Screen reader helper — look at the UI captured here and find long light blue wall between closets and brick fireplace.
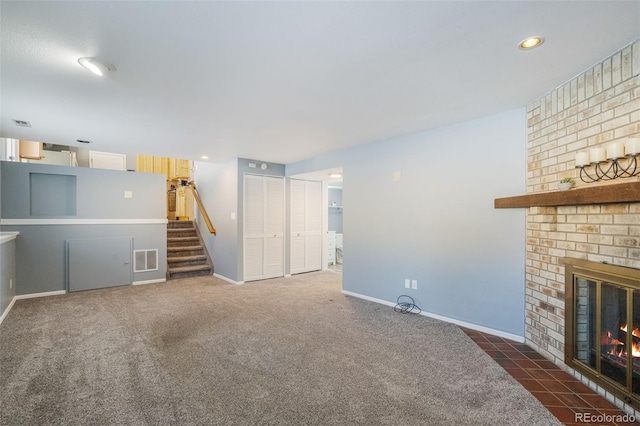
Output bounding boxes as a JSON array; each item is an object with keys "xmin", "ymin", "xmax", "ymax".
[{"xmin": 287, "ymin": 109, "xmax": 526, "ymax": 336}]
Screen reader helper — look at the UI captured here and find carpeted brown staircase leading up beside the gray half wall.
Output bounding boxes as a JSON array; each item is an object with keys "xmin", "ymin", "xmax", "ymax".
[{"xmin": 167, "ymin": 220, "xmax": 213, "ymax": 280}]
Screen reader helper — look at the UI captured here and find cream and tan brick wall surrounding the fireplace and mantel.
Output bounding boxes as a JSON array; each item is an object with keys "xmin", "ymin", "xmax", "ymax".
[{"xmin": 525, "ymin": 40, "xmax": 640, "ymax": 364}]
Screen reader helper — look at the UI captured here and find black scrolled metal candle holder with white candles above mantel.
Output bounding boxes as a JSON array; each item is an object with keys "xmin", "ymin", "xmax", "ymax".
[{"xmin": 576, "ymin": 138, "xmax": 640, "ymax": 183}]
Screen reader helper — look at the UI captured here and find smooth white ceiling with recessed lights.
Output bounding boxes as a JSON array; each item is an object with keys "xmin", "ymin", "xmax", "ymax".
[{"xmin": 0, "ymin": 0, "xmax": 640, "ymax": 163}]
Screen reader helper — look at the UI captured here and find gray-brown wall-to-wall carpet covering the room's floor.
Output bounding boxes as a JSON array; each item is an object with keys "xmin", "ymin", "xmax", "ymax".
[{"xmin": 0, "ymin": 272, "xmax": 560, "ymax": 425}]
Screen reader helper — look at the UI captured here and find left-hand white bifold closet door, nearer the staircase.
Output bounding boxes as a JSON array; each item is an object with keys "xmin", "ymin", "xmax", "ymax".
[{"xmin": 243, "ymin": 175, "xmax": 285, "ymax": 281}]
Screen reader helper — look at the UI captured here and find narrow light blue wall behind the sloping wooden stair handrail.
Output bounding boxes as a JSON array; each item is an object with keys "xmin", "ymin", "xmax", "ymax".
[{"xmin": 194, "ymin": 159, "xmax": 241, "ymax": 281}]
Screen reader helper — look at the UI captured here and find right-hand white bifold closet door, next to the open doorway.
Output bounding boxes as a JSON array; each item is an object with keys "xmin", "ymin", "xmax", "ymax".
[{"xmin": 290, "ymin": 180, "xmax": 322, "ymax": 274}]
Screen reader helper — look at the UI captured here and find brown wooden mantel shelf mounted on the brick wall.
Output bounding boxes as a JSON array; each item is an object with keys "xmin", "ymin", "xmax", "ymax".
[{"xmin": 494, "ymin": 182, "xmax": 640, "ymax": 209}]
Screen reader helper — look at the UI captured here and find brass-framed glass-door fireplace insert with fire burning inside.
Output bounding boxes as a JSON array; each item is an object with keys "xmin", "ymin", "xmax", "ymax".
[{"xmin": 565, "ymin": 259, "xmax": 640, "ymax": 407}]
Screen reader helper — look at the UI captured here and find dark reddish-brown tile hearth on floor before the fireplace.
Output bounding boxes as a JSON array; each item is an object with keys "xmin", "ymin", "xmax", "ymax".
[{"xmin": 461, "ymin": 327, "xmax": 640, "ymax": 425}]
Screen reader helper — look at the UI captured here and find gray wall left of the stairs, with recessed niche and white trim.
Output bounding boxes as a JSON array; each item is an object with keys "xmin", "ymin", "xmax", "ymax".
[{"xmin": 0, "ymin": 162, "xmax": 167, "ymax": 295}]
